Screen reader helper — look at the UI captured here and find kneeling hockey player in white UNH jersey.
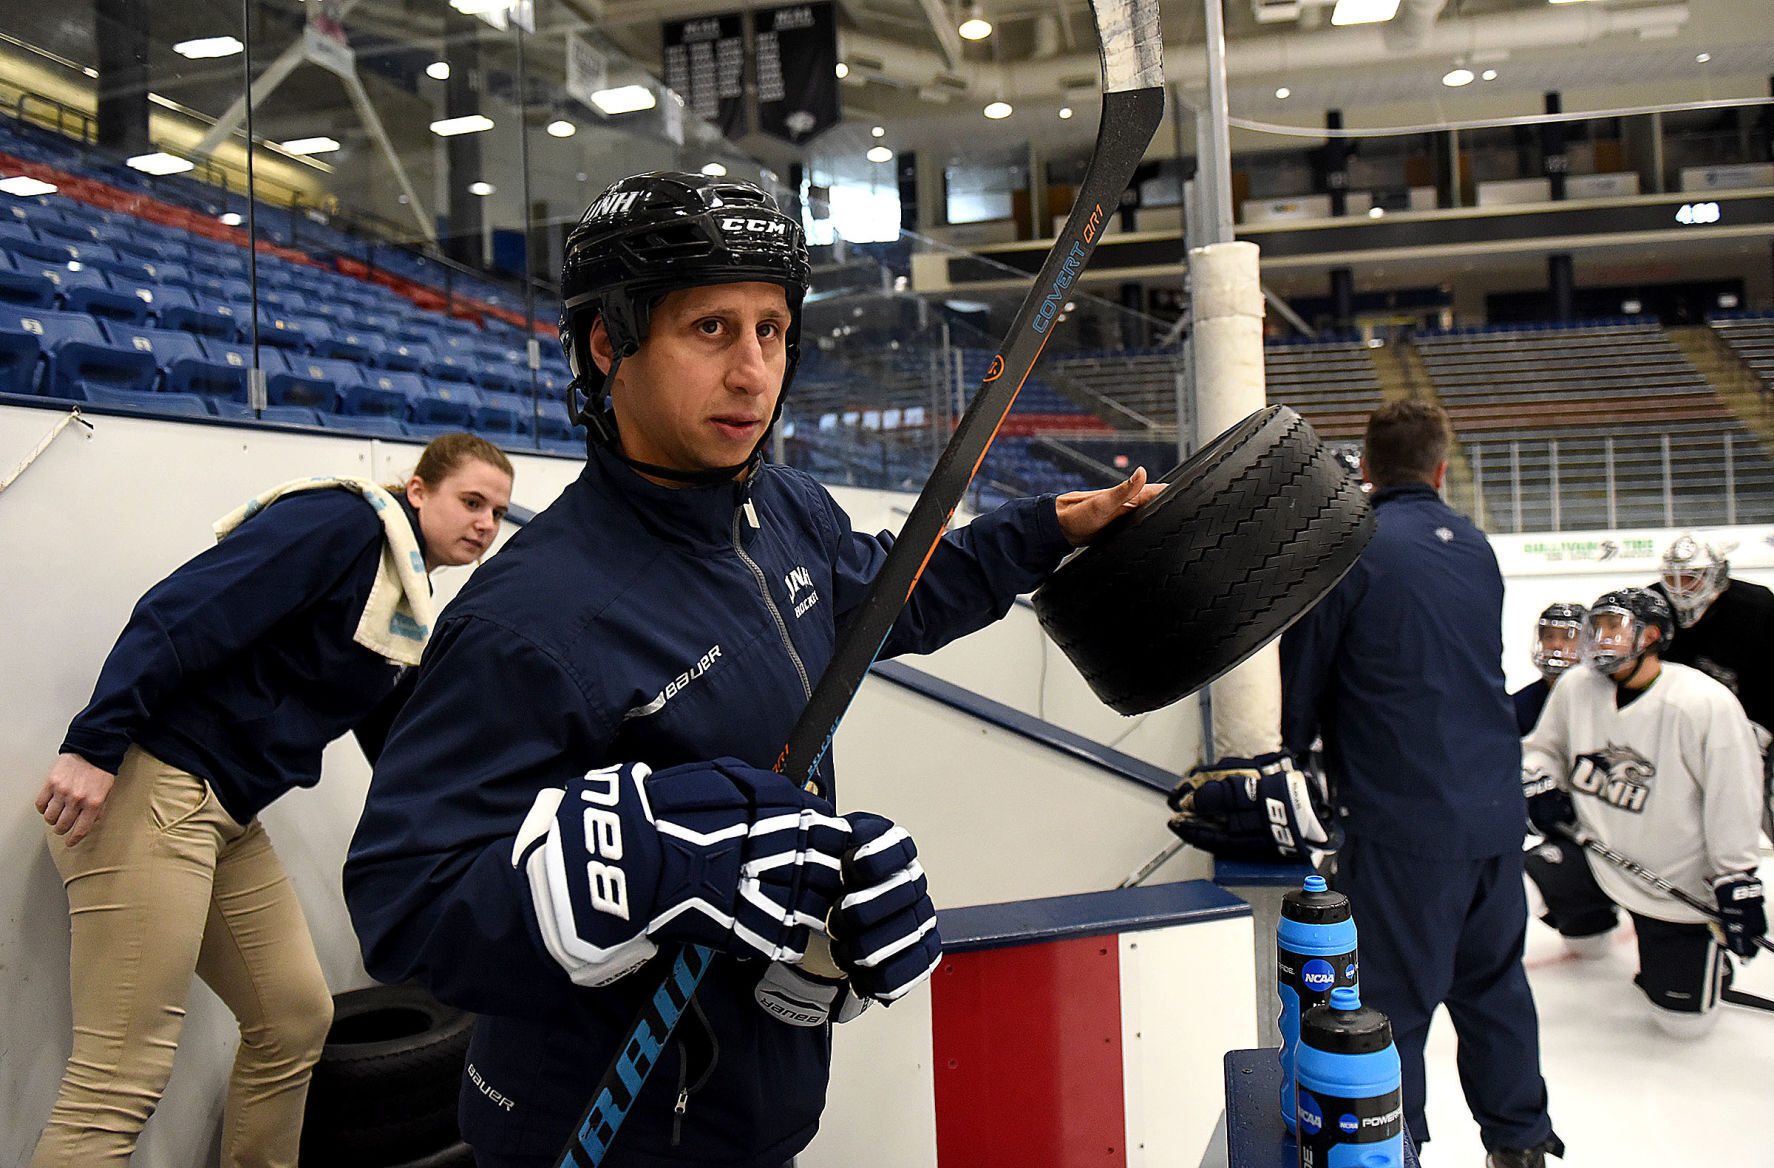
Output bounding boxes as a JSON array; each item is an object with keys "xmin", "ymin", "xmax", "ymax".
[{"xmin": 1522, "ymin": 588, "xmax": 1767, "ymax": 1037}]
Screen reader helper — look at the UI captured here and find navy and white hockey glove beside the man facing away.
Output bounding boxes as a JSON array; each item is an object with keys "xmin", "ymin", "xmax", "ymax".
[{"xmin": 1167, "ymin": 751, "xmax": 1341, "ymax": 861}]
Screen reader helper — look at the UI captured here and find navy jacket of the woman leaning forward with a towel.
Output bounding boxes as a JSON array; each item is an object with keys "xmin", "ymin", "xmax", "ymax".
[{"xmin": 62, "ymin": 488, "xmax": 424, "ymax": 824}]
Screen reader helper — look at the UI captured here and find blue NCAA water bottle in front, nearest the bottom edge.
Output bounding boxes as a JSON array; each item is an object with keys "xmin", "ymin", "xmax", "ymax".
[{"xmin": 1297, "ymin": 985, "xmax": 1405, "ymax": 1168}]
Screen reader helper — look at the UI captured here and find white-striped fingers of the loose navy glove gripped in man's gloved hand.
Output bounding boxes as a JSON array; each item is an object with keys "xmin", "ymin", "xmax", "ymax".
[{"xmin": 832, "ymin": 811, "xmax": 942, "ymax": 1003}]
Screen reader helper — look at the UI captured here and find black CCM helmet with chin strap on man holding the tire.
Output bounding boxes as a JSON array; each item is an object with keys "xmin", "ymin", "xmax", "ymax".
[{"xmin": 561, "ymin": 170, "xmax": 812, "ymax": 483}]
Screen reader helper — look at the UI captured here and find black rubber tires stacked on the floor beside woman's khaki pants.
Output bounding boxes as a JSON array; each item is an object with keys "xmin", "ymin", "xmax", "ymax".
[{"xmin": 302, "ymin": 985, "xmax": 474, "ymax": 1168}]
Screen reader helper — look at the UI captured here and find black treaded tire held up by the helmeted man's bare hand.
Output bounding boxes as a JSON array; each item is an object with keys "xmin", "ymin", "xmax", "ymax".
[{"xmin": 1034, "ymin": 405, "xmax": 1373, "ymax": 714}]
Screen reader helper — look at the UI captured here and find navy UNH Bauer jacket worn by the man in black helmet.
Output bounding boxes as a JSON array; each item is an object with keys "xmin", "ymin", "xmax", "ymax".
[{"xmin": 344, "ymin": 441, "xmax": 1068, "ymax": 1168}]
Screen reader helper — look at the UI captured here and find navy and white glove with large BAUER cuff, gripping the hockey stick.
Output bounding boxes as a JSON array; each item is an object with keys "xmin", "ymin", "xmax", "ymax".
[{"xmin": 511, "ymin": 758, "xmax": 852, "ymax": 985}]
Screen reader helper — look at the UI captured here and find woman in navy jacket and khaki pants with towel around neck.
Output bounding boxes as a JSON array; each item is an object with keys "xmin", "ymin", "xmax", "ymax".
[{"xmin": 32, "ymin": 435, "xmax": 511, "ymax": 1168}]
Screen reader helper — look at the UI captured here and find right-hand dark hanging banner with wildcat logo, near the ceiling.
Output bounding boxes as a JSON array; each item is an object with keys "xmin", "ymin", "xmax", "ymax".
[{"xmin": 752, "ymin": 0, "xmax": 843, "ymax": 146}]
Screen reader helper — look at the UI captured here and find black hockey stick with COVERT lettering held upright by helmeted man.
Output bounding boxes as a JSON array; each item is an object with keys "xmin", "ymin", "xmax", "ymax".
[{"xmin": 557, "ymin": 9, "xmax": 1164, "ymax": 1168}]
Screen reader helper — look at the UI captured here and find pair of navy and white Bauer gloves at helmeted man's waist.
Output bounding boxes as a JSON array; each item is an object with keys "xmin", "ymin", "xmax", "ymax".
[{"xmin": 511, "ymin": 758, "xmax": 942, "ymax": 1026}]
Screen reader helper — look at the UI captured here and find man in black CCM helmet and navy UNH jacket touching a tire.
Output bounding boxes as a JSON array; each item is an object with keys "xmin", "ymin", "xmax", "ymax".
[{"xmin": 346, "ymin": 165, "xmax": 1157, "ymax": 1168}]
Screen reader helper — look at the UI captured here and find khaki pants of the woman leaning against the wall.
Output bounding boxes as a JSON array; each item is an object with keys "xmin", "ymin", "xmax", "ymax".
[{"xmin": 32, "ymin": 747, "xmax": 332, "ymax": 1168}]
